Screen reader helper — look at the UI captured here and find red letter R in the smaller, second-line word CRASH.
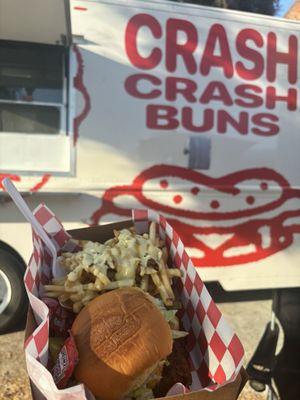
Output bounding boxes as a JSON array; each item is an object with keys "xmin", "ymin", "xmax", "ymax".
[{"xmin": 166, "ymin": 77, "xmax": 197, "ymax": 103}]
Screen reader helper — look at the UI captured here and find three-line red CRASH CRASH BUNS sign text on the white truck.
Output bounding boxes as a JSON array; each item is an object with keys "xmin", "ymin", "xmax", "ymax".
[{"xmin": 124, "ymin": 14, "xmax": 298, "ymax": 137}]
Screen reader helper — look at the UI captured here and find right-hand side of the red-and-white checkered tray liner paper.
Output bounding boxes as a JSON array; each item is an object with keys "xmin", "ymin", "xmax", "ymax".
[{"xmin": 133, "ymin": 210, "xmax": 244, "ymax": 390}]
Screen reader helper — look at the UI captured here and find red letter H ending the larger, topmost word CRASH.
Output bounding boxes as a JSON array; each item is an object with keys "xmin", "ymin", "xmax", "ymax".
[{"xmin": 267, "ymin": 32, "xmax": 298, "ymax": 84}]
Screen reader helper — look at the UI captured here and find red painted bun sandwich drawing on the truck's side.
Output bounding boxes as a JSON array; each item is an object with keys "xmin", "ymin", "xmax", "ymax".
[{"xmin": 91, "ymin": 165, "xmax": 300, "ymax": 267}]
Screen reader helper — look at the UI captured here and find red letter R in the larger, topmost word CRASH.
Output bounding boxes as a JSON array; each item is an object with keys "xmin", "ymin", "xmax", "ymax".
[{"xmin": 166, "ymin": 18, "xmax": 198, "ymax": 74}]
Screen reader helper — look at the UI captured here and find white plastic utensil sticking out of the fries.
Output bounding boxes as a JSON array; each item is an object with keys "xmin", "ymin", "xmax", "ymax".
[{"xmin": 2, "ymin": 178, "xmax": 65, "ymax": 277}]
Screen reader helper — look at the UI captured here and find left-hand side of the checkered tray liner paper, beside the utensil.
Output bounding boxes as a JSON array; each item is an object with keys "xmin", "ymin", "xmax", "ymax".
[{"xmin": 24, "ymin": 204, "xmax": 87, "ymax": 400}]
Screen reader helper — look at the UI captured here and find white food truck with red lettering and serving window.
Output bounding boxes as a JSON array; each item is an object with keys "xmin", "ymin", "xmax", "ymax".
[{"xmin": 0, "ymin": 0, "xmax": 300, "ymax": 338}]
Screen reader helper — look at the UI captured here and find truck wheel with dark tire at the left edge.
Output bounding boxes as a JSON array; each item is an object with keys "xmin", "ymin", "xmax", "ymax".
[{"xmin": 0, "ymin": 249, "xmax": 28, "ymax": 334}]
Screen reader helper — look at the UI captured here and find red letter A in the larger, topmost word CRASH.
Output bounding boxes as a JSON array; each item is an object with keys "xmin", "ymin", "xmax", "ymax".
[{"xmin": 200, "ymin": 24, "xmax": 233, "ymax": 78}]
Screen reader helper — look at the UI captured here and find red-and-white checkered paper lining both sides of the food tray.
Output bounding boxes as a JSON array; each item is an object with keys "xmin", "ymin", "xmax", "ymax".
[{"xmin": 24, "ymin": 205, "xmax": 244, "ymax": 400}]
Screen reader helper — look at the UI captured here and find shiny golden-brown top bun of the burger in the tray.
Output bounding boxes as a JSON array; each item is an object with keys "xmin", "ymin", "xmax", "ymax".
[{"xmin": 71, "ymin": 288, "xmax": 172, "ymax": 400}]
